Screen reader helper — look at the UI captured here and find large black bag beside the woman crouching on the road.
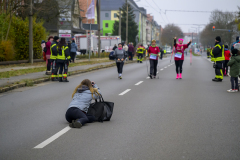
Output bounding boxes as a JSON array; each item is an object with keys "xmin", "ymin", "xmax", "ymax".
[{"xmin": 87, "ymin": 95, "xmax": 114, "ymax": 122}]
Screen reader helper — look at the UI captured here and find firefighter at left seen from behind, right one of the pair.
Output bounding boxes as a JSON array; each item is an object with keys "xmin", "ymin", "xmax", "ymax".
[{"xmin": 55, "ymin": 38, "xmax": 71, "ymax": 82}]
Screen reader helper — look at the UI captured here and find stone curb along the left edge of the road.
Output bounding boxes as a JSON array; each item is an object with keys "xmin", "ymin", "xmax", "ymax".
[{"xmin": 0, "ymin": 60, "xmax": 136, "ymax": 93}]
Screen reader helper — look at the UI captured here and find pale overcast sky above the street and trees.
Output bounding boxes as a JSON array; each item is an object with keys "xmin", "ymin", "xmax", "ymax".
[{"xmin": 135, "ymin": 0, "xmax": 240, "ymax": 32}]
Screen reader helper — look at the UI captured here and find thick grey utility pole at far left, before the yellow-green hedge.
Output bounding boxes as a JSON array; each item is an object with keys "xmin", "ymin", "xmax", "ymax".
[{"xmin": 29, "ymin": 0, "xmax": 33, "ymax": 64}]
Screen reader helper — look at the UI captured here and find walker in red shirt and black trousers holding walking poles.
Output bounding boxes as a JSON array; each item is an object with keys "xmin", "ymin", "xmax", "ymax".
[{"xmin": 148, "ymin": 40, "xmax": 160, "ymax": 79}]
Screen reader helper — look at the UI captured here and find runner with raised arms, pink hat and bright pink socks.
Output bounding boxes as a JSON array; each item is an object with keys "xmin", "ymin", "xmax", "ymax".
[{"xmin": 174, "ymin": 37, "xmax": 192, "ymax": 79}]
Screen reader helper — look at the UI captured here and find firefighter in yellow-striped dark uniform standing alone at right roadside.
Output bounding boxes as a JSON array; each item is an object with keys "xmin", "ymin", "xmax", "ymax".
[{"xmin": 211, "ymin": 36, "xmax": 225, "ymax": 82}]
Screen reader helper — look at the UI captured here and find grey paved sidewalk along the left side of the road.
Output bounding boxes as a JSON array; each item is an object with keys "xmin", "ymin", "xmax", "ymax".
[{"xmin": 0, "ymin": 60, "xmax": 115, "ymax": 87}]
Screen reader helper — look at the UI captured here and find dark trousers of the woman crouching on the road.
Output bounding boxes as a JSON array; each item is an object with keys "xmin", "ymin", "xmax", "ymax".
[{"xmin": 65, "ymin": 107, "xmax": 95, "ymax": 125}]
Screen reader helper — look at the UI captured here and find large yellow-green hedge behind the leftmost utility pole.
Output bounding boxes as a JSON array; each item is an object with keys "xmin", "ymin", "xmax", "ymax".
[{"xmin": 0, "ymin": 14, "xmax": 47, "ymax": 60}]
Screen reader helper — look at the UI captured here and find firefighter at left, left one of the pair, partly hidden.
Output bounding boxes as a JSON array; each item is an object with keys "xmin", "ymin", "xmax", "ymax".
[{"xmin": 48, "ymin": 36, "xmax": 59, "ymax": 81}]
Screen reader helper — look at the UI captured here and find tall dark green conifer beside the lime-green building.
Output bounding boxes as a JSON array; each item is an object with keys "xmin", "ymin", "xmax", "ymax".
[{"xmin": 113, "ymin": 0, "xmax": 138, "ymax": 44}]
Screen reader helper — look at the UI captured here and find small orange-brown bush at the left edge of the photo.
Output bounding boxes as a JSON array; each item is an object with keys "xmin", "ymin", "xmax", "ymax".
[{"xmin": 0, "ymin": 40, "xmax": 15, "ymax": 61}]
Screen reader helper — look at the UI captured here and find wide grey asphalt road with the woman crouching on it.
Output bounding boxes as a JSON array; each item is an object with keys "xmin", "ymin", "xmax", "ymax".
[{"xmin": 0, "ymin": 53, "xmax": 240, "ymax": 160}]
